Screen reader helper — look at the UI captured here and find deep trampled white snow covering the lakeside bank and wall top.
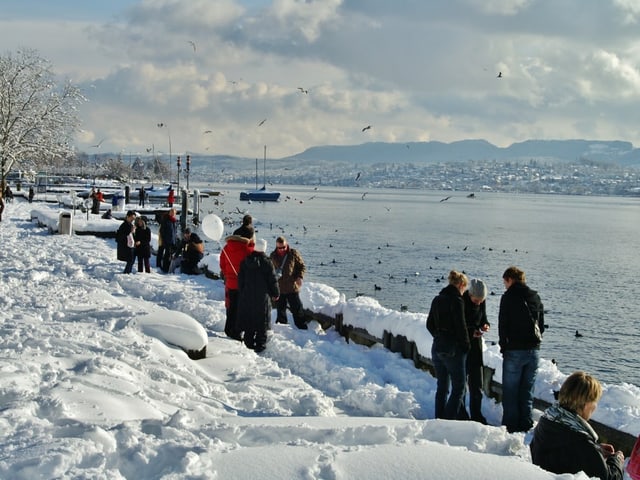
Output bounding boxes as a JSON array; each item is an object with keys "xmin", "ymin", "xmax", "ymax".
[{"xmin": 0, "ymin": 193, "xmax": 640, "ymax": 480}]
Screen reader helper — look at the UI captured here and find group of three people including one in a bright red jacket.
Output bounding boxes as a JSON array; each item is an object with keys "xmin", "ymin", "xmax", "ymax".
[{"xmin": 220, "ymin": 215, "xmax": 308, "ymax": 352}]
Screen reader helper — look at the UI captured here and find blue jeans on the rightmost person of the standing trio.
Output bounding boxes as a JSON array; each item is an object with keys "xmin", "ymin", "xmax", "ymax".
[{"xmin": 502, "ymin": 349, "xmax": 540, "ymax": 432}]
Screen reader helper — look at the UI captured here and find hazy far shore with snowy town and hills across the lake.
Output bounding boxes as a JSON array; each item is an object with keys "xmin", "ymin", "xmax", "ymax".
[{"xmin": 16, "ymin": 140, "xmax": 640, "ymax": 197}]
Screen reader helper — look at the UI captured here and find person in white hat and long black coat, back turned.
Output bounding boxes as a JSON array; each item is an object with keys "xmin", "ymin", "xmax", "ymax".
[{"xmin": 238, "ymin": 238, "xmax": 280, "ymax": 353}]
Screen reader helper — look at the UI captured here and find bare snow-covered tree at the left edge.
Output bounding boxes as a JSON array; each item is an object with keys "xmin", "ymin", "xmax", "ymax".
[{"xmin": 0, "ymin": 49, "xmax": 86, "ymax": 185}]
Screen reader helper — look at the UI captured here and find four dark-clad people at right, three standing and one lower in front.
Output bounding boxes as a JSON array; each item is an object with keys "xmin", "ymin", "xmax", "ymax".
[{"xmin": 427, "ymin": 266, "xmax": 624, "ymax": 480}]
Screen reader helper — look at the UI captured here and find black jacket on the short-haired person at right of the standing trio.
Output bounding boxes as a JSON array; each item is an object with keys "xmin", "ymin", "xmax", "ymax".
[{"xmin": 498, "ymin": 283, "xmax": 544, "ymax": 352}]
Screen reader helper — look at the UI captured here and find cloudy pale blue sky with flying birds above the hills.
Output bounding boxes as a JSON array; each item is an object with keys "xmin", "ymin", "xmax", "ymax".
[{"xmin": 0, "ymin": 0, "xmax": 640, "ymax": 158}]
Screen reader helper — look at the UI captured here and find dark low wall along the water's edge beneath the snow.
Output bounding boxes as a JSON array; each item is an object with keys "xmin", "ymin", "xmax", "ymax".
[{"xmin": 307, "ymin": 310, "xmax": 636, "ymax": 456}]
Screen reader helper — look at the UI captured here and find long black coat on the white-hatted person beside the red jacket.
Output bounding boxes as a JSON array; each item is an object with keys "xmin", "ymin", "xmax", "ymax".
[{"xmin": 238, "ymin": 252, "xmax": 280, "ymax": 330}]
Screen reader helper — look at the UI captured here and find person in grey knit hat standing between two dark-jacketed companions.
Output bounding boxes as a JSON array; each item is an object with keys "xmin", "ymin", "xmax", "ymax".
[{"xmin": 462, "ymin": 278, "xmax": 490, "ymax": 425}]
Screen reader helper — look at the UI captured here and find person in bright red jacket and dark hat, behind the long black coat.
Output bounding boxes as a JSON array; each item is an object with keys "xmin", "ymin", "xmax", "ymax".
[{"xmin": 220, "ymin": 228, "xmax": 255, "ymax": 341}]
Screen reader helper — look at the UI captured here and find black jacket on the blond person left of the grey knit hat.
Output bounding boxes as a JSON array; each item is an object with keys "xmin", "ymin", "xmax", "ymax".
[{"xmin": 427, "ymin": 285, "xmax": 470, "ymax": 352}]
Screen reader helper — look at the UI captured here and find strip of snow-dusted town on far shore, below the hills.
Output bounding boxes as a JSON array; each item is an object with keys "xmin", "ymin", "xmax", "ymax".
[{"xmin": 220, "ymin": 160, "xmax": 640, "ymax": 196}]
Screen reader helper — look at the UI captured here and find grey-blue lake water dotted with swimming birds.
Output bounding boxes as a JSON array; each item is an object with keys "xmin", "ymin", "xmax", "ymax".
[{"xmin": 201, "ymin": 185, "xmax": 640, "ymax": 385}]
